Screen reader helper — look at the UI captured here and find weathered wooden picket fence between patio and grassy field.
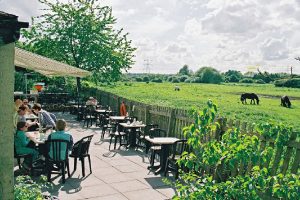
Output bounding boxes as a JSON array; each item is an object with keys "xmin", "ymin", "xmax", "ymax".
[{"xmin": 90, "ymin": 90, "xmax": 300, "ymax": 176}]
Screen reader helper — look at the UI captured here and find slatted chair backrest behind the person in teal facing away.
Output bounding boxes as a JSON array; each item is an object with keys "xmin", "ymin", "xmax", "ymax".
[{"xmin": 46, "ymin": 139, "xmax": 69, "ymax": 161}]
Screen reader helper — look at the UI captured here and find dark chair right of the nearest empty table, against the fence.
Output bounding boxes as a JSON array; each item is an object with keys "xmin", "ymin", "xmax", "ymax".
[{"xmin": 164, "ymin": 139, "xmax": 187, "ymax": 179}]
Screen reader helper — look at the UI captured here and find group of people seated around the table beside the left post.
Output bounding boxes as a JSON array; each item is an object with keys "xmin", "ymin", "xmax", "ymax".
[{"xmin": 14, "ymin": 99, "xmax": 73, "ymax": 170}]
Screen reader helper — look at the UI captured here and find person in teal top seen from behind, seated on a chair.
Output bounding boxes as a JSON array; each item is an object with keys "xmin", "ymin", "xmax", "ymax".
[{"xmin": 48, "ymin": 119, "xmax": 73, "ymax": 158}]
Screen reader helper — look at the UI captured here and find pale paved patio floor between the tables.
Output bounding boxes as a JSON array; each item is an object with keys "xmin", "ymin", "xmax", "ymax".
[{"xmin": 15, "ymin": 113, "xmax": 175, "ymax": 200}]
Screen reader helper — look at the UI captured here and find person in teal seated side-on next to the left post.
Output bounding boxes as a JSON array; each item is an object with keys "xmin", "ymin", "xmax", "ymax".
[{"xmin": 15, "ymin": 122, "xmax": 39, "ymax": 170}]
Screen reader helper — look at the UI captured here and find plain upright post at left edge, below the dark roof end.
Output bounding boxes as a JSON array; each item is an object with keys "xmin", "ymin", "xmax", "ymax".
[{"xmin": 0, "ymin": 43, "xmax": 15, "ymax": 199}]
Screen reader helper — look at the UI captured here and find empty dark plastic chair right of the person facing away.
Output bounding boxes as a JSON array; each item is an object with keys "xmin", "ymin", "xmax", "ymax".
[{"xmin": 69, "ymin": 135, "xmax": 94, "ymax": 176}]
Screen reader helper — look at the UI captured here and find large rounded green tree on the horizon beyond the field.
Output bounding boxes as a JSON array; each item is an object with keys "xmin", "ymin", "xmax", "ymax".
[{"xmin": 195, "ymin": 67, "xmax": 223, "ymax": 83}]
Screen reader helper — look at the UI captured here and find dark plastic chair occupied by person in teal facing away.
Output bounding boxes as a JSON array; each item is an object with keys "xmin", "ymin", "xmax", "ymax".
[{"xmin": 46, "ymin": 139, "xmax": 71, "ymax": 183}]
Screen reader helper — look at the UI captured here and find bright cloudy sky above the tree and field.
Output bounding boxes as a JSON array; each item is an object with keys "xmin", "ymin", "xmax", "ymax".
[{"xmin": 0, "ymin": 0, "xmax": 300, "ymax": 74}]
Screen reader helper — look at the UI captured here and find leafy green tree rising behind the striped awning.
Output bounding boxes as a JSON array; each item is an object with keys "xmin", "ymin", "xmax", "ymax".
[{"xmin": 22, "ymin": 0, "xmax": 135, "ymax": 82}]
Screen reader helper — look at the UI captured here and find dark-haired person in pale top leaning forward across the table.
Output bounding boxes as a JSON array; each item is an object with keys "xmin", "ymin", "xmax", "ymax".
[{"xmin": 32, "ymin": 103, "xmax": 56, "ymax": 128}]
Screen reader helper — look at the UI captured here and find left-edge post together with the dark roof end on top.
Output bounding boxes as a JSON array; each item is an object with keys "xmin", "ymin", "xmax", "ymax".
[{"xmin": 0, "ymin": 12, "xmax": 29, "ymax": 200}]
